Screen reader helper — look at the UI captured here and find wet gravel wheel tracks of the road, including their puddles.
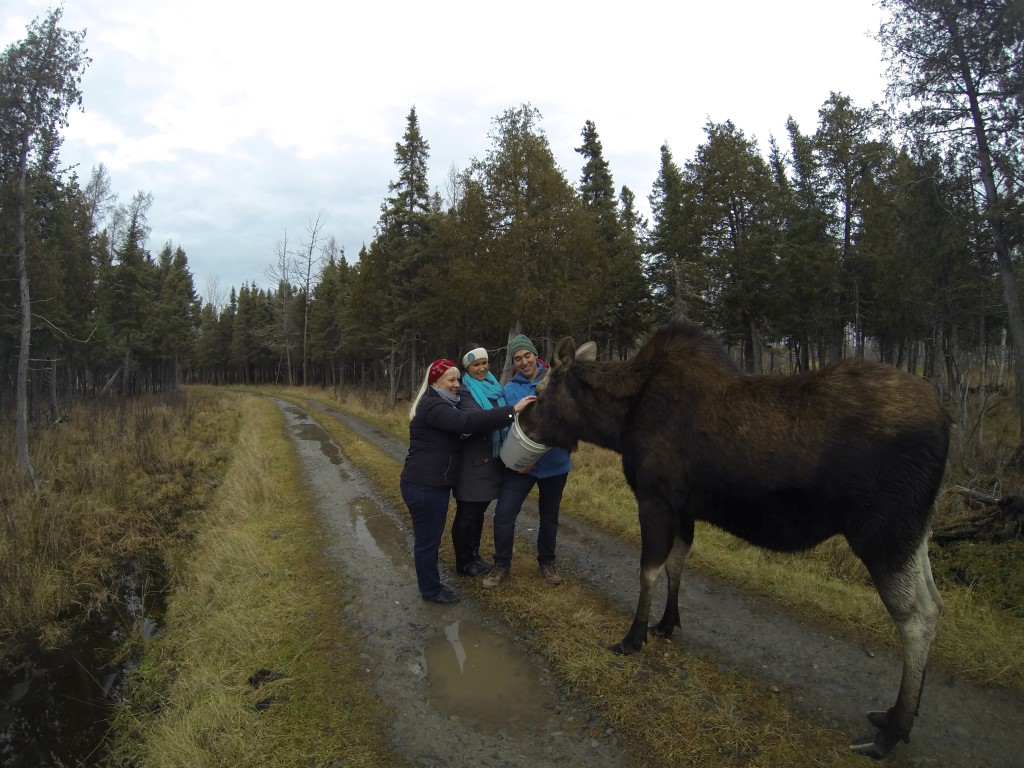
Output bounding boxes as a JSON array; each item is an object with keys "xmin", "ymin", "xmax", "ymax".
[{"xmin": 276, "ymin": 400, "xmax": 1024, "ymax": 768}]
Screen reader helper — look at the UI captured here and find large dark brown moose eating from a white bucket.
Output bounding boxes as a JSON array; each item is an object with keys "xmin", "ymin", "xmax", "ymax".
[{"xmin": 520, "ymin": 323, "xmax": 950, "ymax": 759}]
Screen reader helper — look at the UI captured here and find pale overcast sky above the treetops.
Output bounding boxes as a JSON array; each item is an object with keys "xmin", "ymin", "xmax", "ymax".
[{"xmin": 0, "ymin": 0, "xmax": 885, "ymax": 299}]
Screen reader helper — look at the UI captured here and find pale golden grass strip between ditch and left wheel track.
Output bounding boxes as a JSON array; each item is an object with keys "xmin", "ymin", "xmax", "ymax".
[{"xmin": 108, "ymin": 397, "xmax": 403, "ymax": 768}]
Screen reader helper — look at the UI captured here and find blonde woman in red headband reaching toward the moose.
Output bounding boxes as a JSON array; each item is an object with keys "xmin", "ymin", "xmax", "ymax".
[{"xmin": 400, "ymin": 357, "xmax": 537, "ymax": 603}]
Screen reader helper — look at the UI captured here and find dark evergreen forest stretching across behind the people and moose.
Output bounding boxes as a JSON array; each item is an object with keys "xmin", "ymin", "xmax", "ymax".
[{"xmin": 0, "ymin": 0, "xmax": 1024, "ymax": 475}]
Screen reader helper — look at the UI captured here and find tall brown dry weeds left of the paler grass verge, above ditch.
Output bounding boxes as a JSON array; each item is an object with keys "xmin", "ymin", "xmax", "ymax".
[{"xmin": 0, "ymin": 394, "xmax": 234, "ymax": 657}]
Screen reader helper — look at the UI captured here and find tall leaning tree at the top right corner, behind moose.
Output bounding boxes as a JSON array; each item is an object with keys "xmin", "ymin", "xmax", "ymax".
[{"xmin": 878, "ymin": 0, "xmax": 1024, "ymax": 450}]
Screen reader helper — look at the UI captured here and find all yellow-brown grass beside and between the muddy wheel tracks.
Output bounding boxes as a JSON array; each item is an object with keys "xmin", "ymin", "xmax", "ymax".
[{"xmin": 0, "ymin": 388, "xmax": 1024, "ymax": 768}]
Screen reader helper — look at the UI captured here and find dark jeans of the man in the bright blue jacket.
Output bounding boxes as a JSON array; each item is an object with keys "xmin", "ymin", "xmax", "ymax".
[{"xmin": 495, "ymin": 469, "xmax": 568, "ymax": 567}]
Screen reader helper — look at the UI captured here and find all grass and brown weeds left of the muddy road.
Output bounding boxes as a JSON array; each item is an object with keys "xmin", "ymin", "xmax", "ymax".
[{"xmin": 0, "ymin": 388, "xmax": 403, "ymax": 768}]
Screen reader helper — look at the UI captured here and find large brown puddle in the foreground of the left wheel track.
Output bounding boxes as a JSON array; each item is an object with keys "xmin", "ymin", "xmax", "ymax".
[{"xmin": 424, "ymin": 622, "xmax": 553, "ymax": 733}]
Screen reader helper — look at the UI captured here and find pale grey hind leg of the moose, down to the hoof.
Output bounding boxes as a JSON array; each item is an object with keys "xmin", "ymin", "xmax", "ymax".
[{"xmin": 850, "ymin": 539, "xmax": 942, "ymax": 759}]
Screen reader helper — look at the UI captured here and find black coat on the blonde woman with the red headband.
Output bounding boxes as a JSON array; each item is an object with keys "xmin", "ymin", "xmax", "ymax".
[{"xmin": 401, "ymin": 387, "xmax": 515, "ymax": 487}]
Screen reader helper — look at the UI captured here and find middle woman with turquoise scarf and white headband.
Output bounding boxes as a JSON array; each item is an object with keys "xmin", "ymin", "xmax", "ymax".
[{"xmin": 452, "ymin": 344, "xmax": 509, "ymax": 577}]
